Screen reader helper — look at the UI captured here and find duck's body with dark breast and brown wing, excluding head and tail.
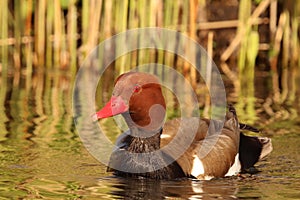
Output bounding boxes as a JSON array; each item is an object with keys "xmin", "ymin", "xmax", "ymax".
[{"xmin": 109, "ymin": 117, "xmax": 239, "ymax": 179}]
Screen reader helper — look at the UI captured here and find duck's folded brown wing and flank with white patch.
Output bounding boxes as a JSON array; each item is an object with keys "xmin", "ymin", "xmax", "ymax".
[{"xmin": 161, "ymin": 108, "xmax": 239, "ymax": 178}]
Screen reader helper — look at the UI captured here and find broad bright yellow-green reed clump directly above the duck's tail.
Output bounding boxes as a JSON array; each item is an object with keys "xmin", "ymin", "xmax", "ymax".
[{"xmin": 237, "ymin": 0, "xmax": 259, "ymax": 122}]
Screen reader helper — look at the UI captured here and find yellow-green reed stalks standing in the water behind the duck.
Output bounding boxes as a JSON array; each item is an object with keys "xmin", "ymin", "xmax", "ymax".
[{"xmin": 0, "ymin": 0, "xmax": 300, "ymax": 120}]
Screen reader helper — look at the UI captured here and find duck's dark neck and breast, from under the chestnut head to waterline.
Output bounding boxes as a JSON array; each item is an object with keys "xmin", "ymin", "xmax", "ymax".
[{"xmin": 110, "ymin": 114, "xmax": 185, "ymax": 179}]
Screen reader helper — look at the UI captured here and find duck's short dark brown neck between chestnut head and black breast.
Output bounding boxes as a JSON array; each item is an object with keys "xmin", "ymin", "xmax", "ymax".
[{"xmin": 126, "ymin": 127, "xmax": 162, "ymax": 153}]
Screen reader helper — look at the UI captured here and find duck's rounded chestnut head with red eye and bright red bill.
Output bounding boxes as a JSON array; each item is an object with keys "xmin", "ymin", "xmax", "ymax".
[{"xmin": 95, "ymin": 72, "xmax": 166, "ymax": 130}]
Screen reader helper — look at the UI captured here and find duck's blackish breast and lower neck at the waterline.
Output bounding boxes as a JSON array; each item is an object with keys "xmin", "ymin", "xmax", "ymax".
[{"xmin": 108, "ymin": 132, "xmax": 185, "ymax": 179}]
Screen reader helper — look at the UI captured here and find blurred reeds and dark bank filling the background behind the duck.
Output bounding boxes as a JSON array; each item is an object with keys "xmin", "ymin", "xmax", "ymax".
[{"xmin": 0, "ymin": 0, "xmax": 300, "ymax": 122}]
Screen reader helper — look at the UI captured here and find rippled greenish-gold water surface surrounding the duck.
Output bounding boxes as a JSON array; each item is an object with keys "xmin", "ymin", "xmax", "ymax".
[{"xmin": 0, "ymin": 73, "xmax": 300, "ymax": 199}]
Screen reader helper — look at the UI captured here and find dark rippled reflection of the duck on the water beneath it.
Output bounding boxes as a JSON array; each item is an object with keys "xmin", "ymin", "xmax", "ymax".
[{"xmin": 105, "ymin": 179, "xmax": 237, "ymax": 199}]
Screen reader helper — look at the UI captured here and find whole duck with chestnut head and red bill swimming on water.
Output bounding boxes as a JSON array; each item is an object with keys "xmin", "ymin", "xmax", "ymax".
[{"xmin": 93, "ymin": 72, "xmax": 272, "ymax": 180}]
